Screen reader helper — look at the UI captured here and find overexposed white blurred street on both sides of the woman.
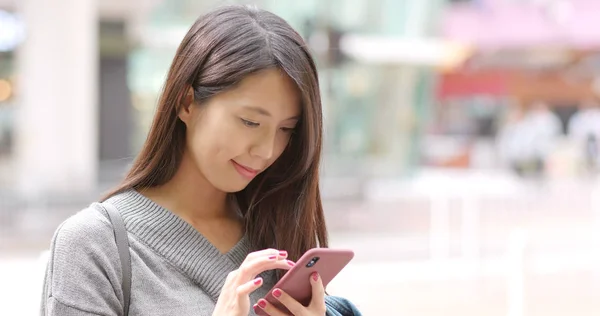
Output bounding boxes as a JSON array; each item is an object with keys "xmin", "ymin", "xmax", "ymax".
[{"xmin": 0, "ymin": 169, "xmax": 600, "ymax": 316}]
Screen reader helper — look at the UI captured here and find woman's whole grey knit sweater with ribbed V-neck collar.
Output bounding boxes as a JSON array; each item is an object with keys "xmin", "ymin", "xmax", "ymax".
[{"xmin": 41, "ymin": 190, "xmax": 275, "ymax": 316}]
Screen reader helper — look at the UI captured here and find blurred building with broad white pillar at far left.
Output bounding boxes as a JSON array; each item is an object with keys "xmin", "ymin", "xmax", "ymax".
[{"xmin": 0, "ymin": 0, "xmax": 156, "ymax": 195}]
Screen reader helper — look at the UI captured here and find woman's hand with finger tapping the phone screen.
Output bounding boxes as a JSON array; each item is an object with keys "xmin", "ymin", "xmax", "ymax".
[{"xmin": 213, "ymin": 249, "xmax": 294, "ymax": 316}]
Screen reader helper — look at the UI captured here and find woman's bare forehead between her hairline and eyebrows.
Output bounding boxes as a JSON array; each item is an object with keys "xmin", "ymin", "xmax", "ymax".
[{"xmin": 214, "ymin": 69, "xmax": 301, "ymax": 118}]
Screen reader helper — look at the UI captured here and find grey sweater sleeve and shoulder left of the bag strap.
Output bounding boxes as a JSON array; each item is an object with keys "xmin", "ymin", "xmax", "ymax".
[{"xmin": 41, "ymin": 206, "xmax": 123, "ymax": 316}]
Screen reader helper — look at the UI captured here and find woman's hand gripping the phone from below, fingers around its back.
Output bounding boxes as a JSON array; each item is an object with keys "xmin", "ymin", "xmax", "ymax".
[{"xmin": 256, "ymin": 272, "xmax": 327, "ymax": 316}]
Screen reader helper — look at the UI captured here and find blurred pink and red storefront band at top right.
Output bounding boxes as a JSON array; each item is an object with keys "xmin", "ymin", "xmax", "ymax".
[{"xmin": 439, "ymin": 0, "xmax": 600, "ymax": 103}]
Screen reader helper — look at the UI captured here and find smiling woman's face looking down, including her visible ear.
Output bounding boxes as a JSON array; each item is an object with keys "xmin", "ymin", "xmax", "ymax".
[{"xmin": 179, "ymin": 69, "xmax": 301, "ymax": 192}]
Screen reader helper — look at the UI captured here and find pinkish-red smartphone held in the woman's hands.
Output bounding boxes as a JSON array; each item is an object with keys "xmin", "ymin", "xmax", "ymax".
[{"xmin": 254, "ymin": 248, "xmax": 354, "ymax": 315}]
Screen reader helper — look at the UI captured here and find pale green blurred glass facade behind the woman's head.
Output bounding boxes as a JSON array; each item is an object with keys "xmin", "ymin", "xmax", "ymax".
[{"xmin": 130, "ymin": 0, "xmax": 443, "ymax": 183}]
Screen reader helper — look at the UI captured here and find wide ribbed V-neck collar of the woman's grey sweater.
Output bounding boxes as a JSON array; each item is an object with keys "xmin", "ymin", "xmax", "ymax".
[{"xmin": 108, "ymin": 190, "xmax": 250, "ymax": 300}]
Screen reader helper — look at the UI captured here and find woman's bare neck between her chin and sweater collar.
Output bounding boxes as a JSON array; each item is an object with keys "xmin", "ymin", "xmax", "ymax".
[{"xmin": 140, "ymin": 153, "xmax": 232, "ymax": 223}]
